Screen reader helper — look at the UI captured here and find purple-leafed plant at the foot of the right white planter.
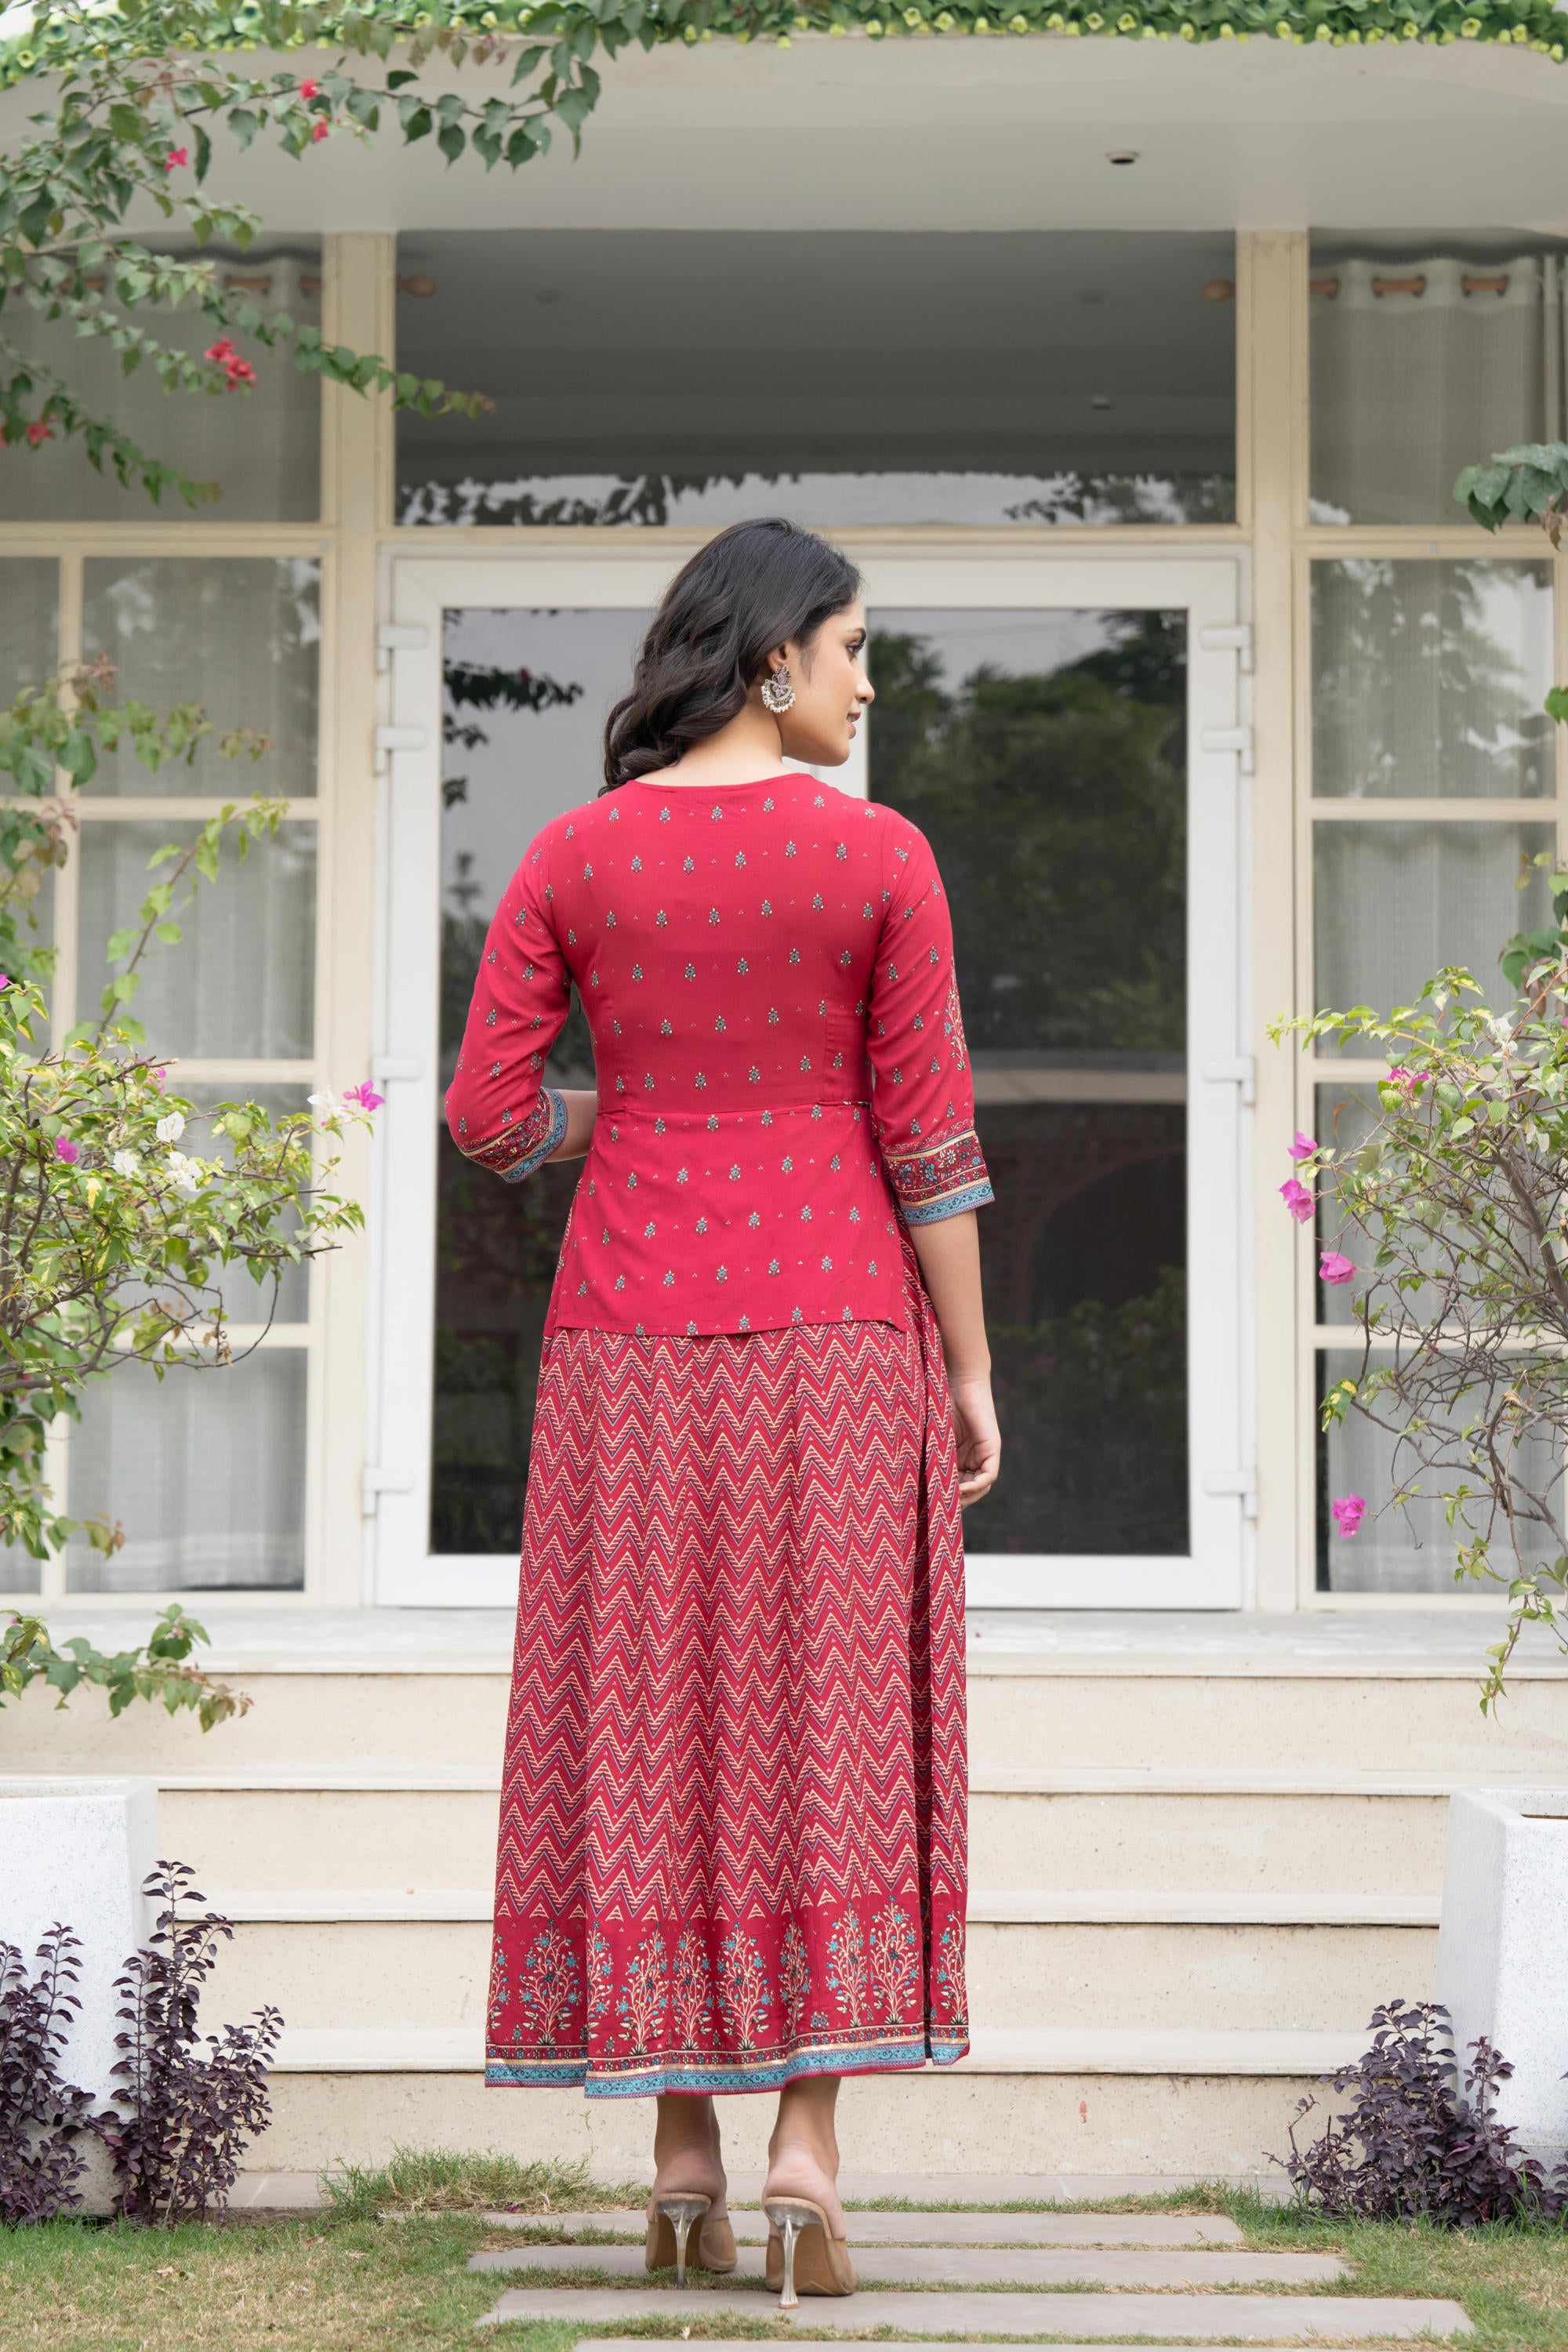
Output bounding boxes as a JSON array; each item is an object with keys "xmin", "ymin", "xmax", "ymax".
[{"xmin": 1269, "ymin": 2002, "xmax": 1566, "ymax": 2230}]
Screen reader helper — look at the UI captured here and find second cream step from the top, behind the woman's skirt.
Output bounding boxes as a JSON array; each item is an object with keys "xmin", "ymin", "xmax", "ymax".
[{"xmin": 160, "ymin": 1769, "xmax": 1504, "ymax": 1898}]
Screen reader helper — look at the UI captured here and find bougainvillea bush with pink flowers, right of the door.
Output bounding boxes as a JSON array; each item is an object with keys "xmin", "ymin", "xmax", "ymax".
[{"xmin": 1269, "ymin": 936, "xmax": 1568, "ymax": 1710}]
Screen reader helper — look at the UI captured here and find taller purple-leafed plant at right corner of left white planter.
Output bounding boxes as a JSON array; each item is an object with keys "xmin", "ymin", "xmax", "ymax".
[{"xmin": 103, "ymin": 1863, "xmax": 282, "ymax": 2227}]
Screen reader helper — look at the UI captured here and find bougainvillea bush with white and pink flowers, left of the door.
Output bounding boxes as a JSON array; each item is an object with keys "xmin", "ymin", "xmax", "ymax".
[{"xmin": 0, "ymin": 666, "xmax": 379, "ymax": 1581}]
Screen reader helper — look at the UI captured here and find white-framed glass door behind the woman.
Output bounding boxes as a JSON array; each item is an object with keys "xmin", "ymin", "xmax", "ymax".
[{"xmin": 367, "ymin": 557, "xmax": 1248, "ymax": 1609}]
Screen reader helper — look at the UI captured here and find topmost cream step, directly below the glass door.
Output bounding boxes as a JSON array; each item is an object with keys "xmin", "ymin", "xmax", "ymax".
[{"xmin": 0, "ymin": 1637, "xmax": 1568, "ymax": 1780}]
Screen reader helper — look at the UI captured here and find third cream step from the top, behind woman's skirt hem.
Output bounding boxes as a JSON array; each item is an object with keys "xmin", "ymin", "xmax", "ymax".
[{"xmin": 199, "ymin": 1891, "xmax": 1436, "ymax": 2030}]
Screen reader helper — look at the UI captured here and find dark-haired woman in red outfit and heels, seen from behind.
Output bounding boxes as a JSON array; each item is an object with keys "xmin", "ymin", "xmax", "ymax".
[{"xmin": 447, "ymin": 522, "xmax": 999, "ymax": 2305}]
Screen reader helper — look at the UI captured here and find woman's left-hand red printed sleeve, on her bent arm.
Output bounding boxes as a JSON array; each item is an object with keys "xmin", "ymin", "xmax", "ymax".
[{"xmin": 447, "ymin": 844, "xmax": 572, "ymax": 1183}]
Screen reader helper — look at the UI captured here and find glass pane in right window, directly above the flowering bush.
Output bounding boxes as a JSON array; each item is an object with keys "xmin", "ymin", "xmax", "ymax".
[{"xmin": 1312, "ymin": 823, "xmax": 1554, "ymax": 1011}]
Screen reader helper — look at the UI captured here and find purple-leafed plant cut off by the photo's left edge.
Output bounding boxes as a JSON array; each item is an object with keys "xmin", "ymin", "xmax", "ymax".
[{"xmin": 0, "ymin": 1922, "xmax": 99, "ymax": 2223}]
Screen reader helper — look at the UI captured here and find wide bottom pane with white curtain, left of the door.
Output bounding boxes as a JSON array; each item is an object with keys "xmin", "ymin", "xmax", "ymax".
[{"xmin": 66, "ymin": 1348, "xmax": 308, "ymax": 1592}]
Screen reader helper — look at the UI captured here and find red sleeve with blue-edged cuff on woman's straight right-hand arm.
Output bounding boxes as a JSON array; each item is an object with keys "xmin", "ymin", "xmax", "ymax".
[{"xmin": 867, "ymin": 823, "xmax": 994, "ymax": 1225}]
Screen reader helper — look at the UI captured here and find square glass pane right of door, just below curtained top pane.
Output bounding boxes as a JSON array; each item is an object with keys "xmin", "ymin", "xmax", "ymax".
[{"xmin": 1312, "ymin": 557, "xmax": 1556, "ymax": 800}]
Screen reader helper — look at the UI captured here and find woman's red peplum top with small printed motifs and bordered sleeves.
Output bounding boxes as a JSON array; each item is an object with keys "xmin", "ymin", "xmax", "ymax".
[{"xmin": 447, "ymin": 774, "xmax": 992, "ymax": 1334}]
